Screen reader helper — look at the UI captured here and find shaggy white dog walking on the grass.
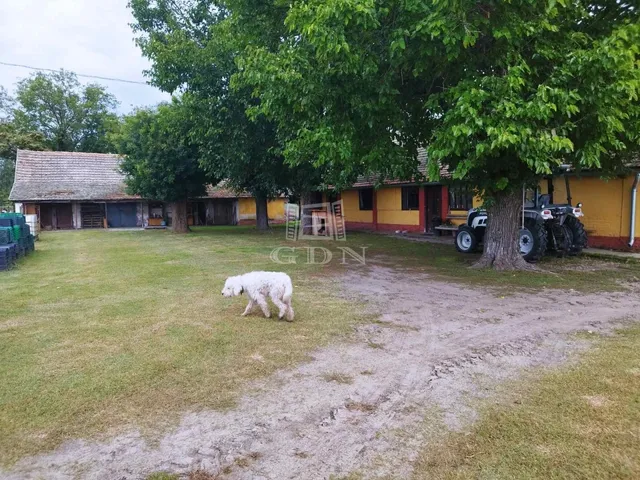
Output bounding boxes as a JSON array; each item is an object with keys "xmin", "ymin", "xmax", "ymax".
[{"xmin": 222, "ymin": 272, "xmax": 293, "ymax": 322}]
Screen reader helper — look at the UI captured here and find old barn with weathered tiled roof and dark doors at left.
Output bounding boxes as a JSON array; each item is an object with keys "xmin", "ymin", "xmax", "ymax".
[{"xmin": 9, "ymin": 150, "xmax": 285, "ymax": 230}]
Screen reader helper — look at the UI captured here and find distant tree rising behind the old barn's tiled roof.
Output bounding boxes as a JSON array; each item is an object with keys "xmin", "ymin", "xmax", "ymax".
[{"xmin": 11, "ymin": 70, "xmax": 118, "ymax": 153}]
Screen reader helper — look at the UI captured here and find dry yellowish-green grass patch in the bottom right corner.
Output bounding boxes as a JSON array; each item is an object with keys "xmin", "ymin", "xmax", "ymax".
[{"xmin": 414, "ymin": 327, "xmax": 640, "ymax": 480}]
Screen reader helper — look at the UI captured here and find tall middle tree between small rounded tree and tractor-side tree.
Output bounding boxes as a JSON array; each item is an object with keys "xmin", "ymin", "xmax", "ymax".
[{"xmin": 130, "ymin": 0, "xmax": 313, "ymax": 229}]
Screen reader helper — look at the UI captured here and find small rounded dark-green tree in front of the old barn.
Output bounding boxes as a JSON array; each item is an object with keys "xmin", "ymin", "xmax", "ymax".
[{"xmin": 118, "ymin": 98, "xmax": 215, "ymax": 233}]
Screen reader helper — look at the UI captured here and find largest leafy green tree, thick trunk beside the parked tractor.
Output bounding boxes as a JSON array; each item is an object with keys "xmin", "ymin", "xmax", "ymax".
[{"xmin": 239, "ymin": 0, "xmax": 640, "ymax": 269}]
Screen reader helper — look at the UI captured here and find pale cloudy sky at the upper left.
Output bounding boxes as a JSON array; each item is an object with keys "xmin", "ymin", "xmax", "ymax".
[{"xmin": 0, "ymin": 0, "xmax": 169, "ymax": 113}]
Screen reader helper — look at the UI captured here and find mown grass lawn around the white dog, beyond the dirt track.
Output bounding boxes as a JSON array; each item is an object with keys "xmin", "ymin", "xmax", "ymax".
[{"xmin": 0, "ymin": 227, "xmax": 640, "ymax": 465}]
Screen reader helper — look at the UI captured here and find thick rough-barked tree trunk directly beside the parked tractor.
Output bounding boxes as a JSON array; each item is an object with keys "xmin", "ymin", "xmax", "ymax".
[{"xmin": 473, "ymin": 191, "xmax": 535, "ymax": 270}]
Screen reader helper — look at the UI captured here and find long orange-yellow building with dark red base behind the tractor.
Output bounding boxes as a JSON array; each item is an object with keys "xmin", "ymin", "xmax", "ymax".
[{"xmin": 341, "ymin": 155, "xmax": 640, "ymax": 250}]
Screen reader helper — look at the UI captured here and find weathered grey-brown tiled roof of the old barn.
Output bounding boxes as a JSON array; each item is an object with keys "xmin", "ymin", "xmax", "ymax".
[{"xmin": 9, "ymin": 150, "xmax": 139, "ymax": 202}]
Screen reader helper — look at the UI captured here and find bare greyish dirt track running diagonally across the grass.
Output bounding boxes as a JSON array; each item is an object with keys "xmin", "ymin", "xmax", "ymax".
[{"xmin": 5, "ymin": 266, "xmax": 640, "ymax": 480}]
